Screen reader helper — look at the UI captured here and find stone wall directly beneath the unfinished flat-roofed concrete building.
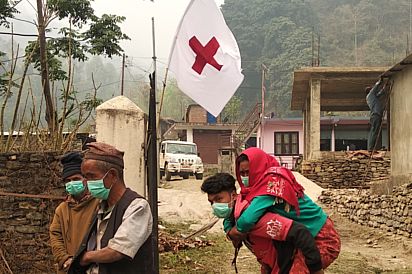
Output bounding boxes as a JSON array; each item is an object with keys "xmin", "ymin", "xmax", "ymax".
[{"xmin": 301, "ymin": 152, "xmax": 391, "ymax": 188}]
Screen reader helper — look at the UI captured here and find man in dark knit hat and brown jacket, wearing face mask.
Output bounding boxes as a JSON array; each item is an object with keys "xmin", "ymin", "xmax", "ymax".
[{"xmin": 50, "ymin": 152, "xmax": 100, "ymax": 274}]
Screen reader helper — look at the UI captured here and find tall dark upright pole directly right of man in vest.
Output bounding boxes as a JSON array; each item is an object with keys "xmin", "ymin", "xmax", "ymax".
[{"xmin": 147, "ymin": 17, "xmax": 159, "ymax": 274}]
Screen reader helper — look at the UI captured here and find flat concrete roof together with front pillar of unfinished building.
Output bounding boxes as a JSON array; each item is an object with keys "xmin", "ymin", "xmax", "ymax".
[{"xmin": 291, "ymin": 67, "xmax": 388, "ymax": 160}]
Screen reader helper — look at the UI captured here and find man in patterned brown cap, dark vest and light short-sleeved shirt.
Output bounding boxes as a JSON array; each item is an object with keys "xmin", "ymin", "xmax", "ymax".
[{"xmin": 69, "ymin": 142, "xmax": 153, "ymax": 274}]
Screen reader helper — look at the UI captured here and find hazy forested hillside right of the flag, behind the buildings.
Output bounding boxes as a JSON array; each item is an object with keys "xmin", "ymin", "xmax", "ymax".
[{"xmin": 222, "ymin": 0, "xmax": 412, "ymax": 117}]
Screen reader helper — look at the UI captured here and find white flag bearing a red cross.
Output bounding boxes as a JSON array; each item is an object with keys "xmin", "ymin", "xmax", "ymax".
[{"xmin": 169, "ymin": 0, "xmax": 243, "ymax": 116}]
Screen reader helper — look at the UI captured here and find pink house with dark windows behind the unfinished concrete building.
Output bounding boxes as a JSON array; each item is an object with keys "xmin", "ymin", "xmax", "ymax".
[{"xmin": 257, "ymin": 116, "xmax": 388, "ymax": 168}]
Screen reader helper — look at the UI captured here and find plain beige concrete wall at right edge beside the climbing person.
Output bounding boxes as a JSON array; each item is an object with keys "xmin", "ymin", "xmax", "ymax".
[{"xmin": 383, "ymin": 55, "xmax": 412, "ymax": 185}]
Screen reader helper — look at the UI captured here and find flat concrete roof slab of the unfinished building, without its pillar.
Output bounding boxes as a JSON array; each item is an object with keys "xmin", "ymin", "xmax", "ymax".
[{"xmin": 291, "ymin": 67, "xmax": 388, "ymax": 111}]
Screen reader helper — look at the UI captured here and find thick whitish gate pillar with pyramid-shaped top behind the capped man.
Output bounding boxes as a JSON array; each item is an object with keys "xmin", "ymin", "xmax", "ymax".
[{"xmin": 96, "ymin": 96, "xmax": 147, "ymax": 197}]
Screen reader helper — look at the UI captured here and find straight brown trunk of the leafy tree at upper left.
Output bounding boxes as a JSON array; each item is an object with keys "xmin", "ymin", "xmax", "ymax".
[{"xmin": 37, "ymin": 0, "xmax": 57, "ymax": 133}]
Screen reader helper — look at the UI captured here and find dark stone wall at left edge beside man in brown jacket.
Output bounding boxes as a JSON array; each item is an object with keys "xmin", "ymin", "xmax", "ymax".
[{"xmin": 0, "ymin": 152, "xmax": 64, "ymax": 273}]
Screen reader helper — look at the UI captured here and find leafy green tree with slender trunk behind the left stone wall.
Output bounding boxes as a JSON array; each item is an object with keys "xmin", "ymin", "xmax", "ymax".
[{"xmin": 26, "ymin": 0, "xmax": 129, "ymax": 133}]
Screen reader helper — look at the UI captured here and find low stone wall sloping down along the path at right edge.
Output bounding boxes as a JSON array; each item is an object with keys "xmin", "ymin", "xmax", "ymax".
[{"xmin": 319, "ymin": 183, "xmax": 412, "ymax": 237}]
